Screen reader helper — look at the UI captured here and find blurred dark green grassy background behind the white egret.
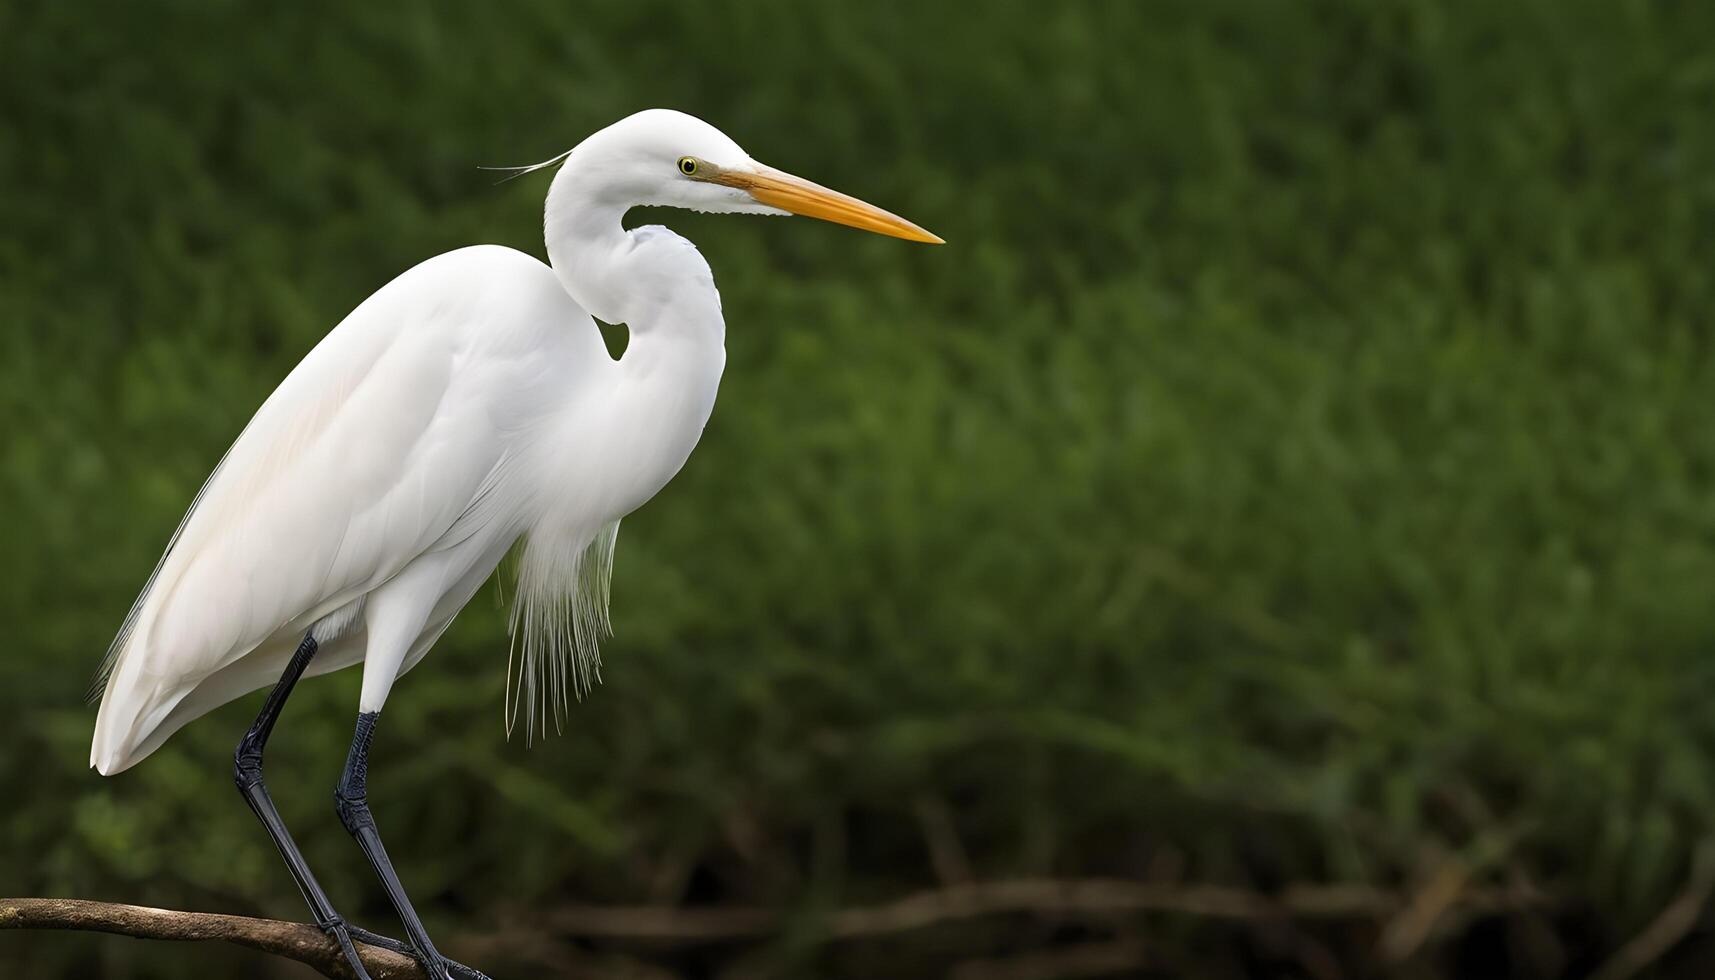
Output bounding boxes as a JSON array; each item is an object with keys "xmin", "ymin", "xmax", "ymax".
[{"xmin": 0, "ymin": 0, "xmax": 1715, "ymax": 980}]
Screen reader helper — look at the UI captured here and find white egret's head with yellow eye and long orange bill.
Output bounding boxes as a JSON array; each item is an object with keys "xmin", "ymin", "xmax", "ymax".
[{"xmin": 568, "ymin": 108, "xmax": 942, "ymax": 244}]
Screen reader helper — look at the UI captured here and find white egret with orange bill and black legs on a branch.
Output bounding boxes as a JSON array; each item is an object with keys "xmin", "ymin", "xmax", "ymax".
[{"xmin": 89, "ymin": 110, "xmax": 940, "ymax": 977}]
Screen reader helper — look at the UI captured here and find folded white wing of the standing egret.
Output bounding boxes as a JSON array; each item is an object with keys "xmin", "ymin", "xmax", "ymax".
[{"xmin": 93, "ymin": 247, "xmax": 599, "ymax": 759}]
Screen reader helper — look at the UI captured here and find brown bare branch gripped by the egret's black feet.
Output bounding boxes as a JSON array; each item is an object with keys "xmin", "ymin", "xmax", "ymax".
[{"xmin": 0, "ymin": 898, "xmax": 482, "ymax": 980}]
